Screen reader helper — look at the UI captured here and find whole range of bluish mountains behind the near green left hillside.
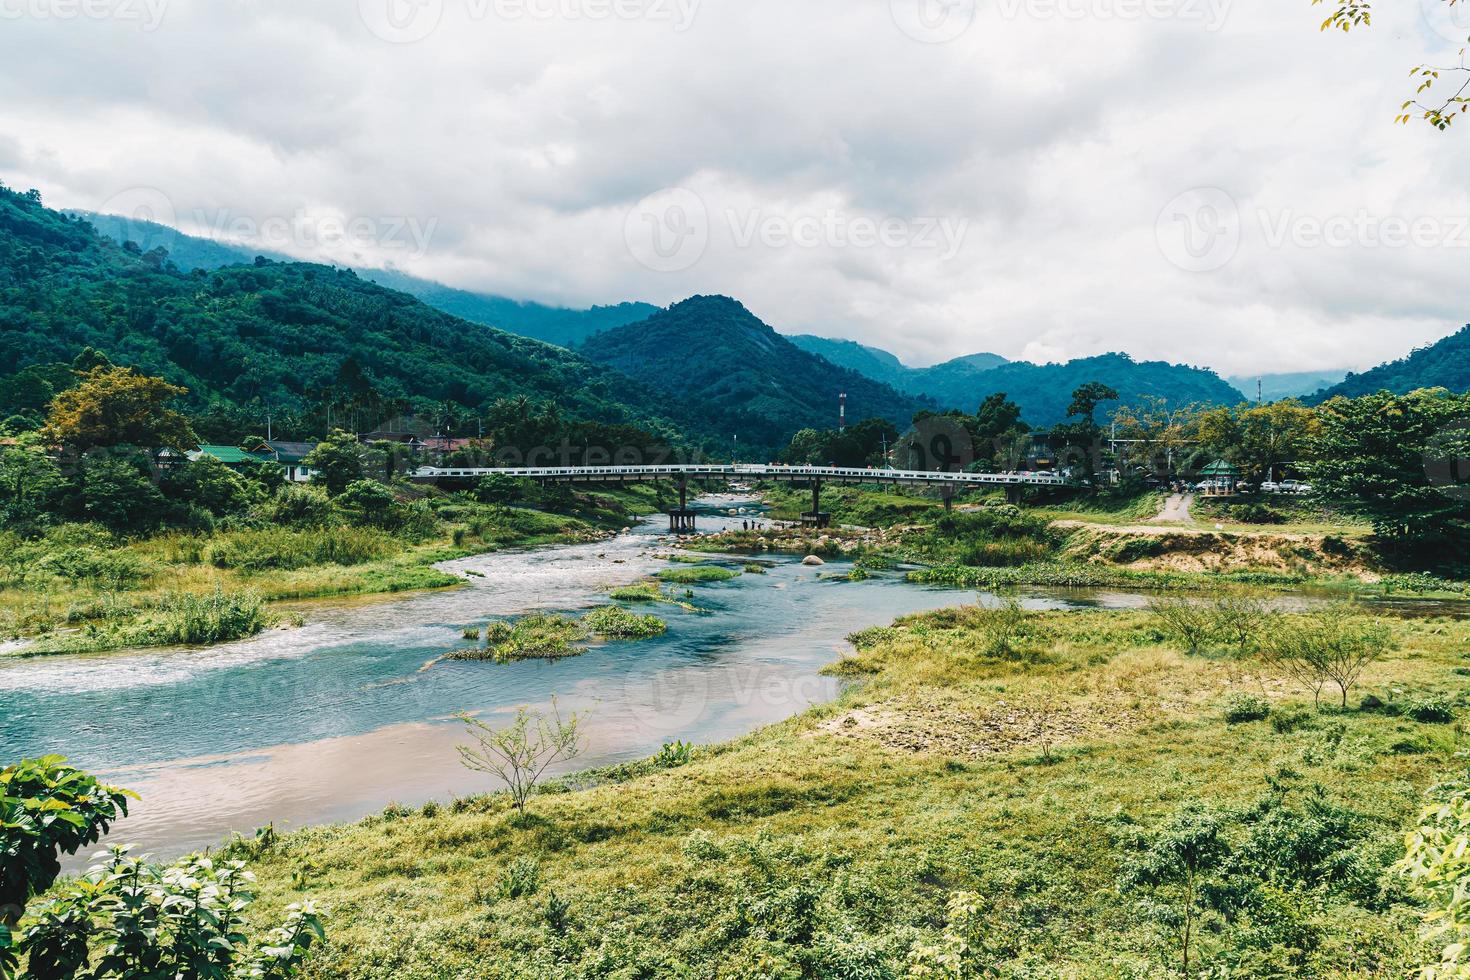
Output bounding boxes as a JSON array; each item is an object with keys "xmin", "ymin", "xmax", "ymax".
[{"xmin": 54, "ymin": 199, "xmax": 1470, "ymax": 437}]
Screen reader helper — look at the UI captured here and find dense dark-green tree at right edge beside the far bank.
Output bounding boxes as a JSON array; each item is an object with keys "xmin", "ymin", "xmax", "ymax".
[{"xmin": 1307, "ymin": 388, "xmax": 1470, "ymax": 554}]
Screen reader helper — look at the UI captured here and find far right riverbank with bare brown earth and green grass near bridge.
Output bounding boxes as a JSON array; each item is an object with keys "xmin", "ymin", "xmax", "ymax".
[{"xmin": 685, "ymin": 486, "xmax": 1470, "ymax": 599}]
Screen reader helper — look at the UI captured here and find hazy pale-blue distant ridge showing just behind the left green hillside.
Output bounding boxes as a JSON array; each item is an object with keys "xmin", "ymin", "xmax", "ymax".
[{"xmin": 69, "ymin": 212, "xmax": 659, "ymax": 347}]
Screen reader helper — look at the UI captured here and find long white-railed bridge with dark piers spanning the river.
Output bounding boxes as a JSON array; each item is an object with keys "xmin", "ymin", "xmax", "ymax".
[{"xmin": 409, "ymin": 463, "xmax": 1070, "ymax": 533}]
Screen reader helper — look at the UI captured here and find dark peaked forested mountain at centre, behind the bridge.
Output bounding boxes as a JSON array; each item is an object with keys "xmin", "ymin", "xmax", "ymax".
[{"xmin": 578, "ymin": 295, "xmax": 922, "ymax": 451}]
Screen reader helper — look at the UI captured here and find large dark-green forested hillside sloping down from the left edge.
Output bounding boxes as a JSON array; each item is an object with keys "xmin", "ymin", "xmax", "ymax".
[{"xmin": 0, "ymin": 188, "xmax": 687, "ymax": 449}]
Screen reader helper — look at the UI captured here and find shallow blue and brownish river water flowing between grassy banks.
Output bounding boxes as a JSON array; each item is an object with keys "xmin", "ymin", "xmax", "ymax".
[{"xmin": 0, "ymin": 500, "xmax": 1458, "ymax": 857}]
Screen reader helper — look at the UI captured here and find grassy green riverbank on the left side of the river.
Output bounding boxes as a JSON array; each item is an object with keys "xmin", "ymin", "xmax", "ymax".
[{"xmin": 0, "ymin": 486, "xmax": 666, "ymax": 657}]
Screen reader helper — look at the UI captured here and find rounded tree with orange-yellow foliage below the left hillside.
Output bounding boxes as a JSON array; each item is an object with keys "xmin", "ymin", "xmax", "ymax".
[{"xmin": 41, "ymin": 367, "xmax": 198, "ymax": 453}]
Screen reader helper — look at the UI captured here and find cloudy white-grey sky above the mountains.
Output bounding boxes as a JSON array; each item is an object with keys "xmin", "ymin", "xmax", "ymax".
[{"xmin": 0, "ymin": 0, "xmax": 1470, "ymax": 373}]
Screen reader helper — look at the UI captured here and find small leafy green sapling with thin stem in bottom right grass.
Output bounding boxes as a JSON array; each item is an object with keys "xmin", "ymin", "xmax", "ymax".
[{"xmin": 1119, "ymin": 802, "xmax": 1230, "ymax": 974}]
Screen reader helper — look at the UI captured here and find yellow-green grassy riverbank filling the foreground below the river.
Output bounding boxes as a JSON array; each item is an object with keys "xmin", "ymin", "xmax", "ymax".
[{"xmin": 235, "ymin": 608, "xmax": 1470, "ymax": 980}]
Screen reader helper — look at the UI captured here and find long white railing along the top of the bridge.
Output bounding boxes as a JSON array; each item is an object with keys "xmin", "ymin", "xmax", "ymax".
[{"xmin": 409, "ymin": 463, "xmax": 1067, "ymax": 486}]
